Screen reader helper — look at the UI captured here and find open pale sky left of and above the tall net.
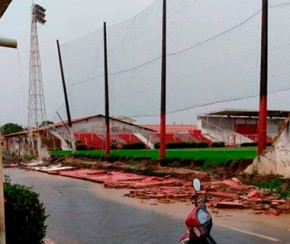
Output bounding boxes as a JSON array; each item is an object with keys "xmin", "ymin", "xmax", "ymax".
[{"xmin": 0, "ymin": 0, "xmax": 156, "ymax": 126}]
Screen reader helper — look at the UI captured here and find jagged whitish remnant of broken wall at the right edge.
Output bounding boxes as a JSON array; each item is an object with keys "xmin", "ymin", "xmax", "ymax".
[{"xmin": 245, "ymin": 116, "xmax": 290, "ymax": 179}]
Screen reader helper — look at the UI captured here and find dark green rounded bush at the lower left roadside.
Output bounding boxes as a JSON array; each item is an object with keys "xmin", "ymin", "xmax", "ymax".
[{"xmin": 4, "ymin": 177, "xmax": 48, "ymax": 244}]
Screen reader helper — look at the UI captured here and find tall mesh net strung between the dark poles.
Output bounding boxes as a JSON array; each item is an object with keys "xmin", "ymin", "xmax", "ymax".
[{"xmin": 58, "ymin": 0, "xmax": 290, "ymax": 123}]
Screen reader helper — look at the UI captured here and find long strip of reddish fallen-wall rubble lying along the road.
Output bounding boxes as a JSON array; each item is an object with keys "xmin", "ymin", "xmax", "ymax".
[{"xmin": 5, "ymin": 161, "xmax": 290, "ymax": 216}]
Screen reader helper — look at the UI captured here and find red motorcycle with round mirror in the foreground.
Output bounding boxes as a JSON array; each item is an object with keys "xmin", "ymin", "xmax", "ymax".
[{"xmin": 179, "ymin": 179, "xmax": 216, "ymax": 244}]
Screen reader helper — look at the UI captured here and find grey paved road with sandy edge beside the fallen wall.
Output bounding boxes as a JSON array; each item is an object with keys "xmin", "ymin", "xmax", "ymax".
[{"xmin": 4, "ymin": 169, "xmax": 290, "ymax": 244}]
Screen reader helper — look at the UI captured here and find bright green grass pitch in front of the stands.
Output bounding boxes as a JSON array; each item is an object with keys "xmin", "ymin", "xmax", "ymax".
[{"xmin": 51, "ymin": 147, "xmax": 257, "ymax": 161}]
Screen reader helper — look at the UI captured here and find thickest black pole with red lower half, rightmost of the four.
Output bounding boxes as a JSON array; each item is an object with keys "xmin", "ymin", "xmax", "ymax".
[{"xmin": 258, "ymin": 0, "xmax": 268, "ymax": 155}]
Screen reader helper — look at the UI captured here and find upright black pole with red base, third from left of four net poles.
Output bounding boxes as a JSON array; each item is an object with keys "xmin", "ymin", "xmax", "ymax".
[{"xmin": 159, "ymin": 0, "xmax": 166, "ymax": 158}]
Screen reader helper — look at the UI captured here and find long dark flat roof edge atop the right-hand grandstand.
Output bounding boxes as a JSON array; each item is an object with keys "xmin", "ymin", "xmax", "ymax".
[{"xmin": 205, "ymin": 109, "xmax": 290, "ymax": 118}]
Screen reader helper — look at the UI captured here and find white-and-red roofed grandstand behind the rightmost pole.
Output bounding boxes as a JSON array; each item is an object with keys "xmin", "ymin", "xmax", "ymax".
[{"xmin": 197, "ymin": 109, "xmax": 289, "ymax": 146}]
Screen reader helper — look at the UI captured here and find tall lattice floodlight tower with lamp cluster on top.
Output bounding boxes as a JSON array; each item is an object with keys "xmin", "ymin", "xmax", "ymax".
[{"xmin": 28, "ymin": 3, "xmax": 46, "ymax": 132}]
